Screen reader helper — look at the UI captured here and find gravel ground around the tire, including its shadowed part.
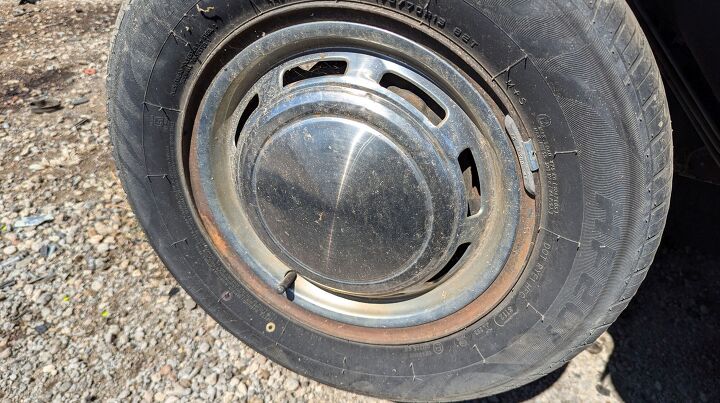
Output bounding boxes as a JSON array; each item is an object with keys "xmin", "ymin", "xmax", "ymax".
[{"xmin": 0, "ymin": 0, "xmax": 720, "ymax": 402}]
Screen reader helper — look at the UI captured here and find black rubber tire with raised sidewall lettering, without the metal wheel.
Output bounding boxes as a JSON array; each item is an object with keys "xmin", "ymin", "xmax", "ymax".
[{"xmin": 108, "ymin": 0, "xmax": 672, "ymax": 401}]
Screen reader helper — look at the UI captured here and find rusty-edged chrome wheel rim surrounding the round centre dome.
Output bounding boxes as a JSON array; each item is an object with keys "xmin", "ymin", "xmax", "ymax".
[{"xmin": 183, "ymin": 15, "xmax": 536, "ymax": 344}]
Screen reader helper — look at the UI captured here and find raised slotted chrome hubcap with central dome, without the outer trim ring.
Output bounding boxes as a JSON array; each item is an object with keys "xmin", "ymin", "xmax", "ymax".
[{"xmin": 235, "ymin": 52, "xmax": 490, "ymax": 297}]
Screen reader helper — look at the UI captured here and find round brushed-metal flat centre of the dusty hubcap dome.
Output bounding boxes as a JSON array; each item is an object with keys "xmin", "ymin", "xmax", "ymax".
[{"xmin": 252, "ymin": 117, "xmax": 432, "ymax": 288}]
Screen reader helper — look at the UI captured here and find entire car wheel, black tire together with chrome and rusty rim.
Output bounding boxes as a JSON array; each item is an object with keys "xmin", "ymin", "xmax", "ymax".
[{"xmin": 108, "ymin": 0, "xmax": 672, "ymax": 401}]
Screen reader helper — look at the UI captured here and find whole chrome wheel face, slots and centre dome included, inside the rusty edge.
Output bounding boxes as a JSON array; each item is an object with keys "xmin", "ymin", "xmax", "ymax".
[{"xmin": 187, "ymin": 23, "xmax": 521, "ymax": 327}]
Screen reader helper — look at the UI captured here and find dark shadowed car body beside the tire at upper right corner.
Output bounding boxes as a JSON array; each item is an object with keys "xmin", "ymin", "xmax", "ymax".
[{"xmin": 632, "ymin": 0, "xmax": 720, "ymax": 184}]
